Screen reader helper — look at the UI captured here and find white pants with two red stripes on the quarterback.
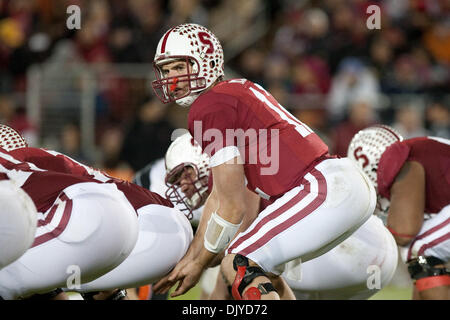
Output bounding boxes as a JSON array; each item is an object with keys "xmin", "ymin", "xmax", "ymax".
[{"xmin": 227, "ymin": 158, "xmax": 376, "ymax": 275}]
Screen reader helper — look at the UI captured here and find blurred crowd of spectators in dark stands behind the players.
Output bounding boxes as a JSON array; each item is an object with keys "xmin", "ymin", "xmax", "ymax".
[{"xmin": 0, "ymin": 0, "xmax": 450, "ymax": 172}]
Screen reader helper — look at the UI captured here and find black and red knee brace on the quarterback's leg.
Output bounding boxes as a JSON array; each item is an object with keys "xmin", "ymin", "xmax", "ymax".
[{"xmin": 231, "ymin": 254, "xmax": 276, "ymax": 300}]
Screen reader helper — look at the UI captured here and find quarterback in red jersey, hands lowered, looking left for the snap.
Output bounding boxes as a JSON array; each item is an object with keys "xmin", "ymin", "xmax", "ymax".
[{"xmin": 153, "ymin": 24, "xmax": 376, "ymax": 299}]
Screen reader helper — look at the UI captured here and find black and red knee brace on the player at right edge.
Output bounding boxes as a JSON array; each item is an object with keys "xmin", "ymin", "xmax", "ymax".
[{"xmin": 408, "ymin": 256, "xmax": 450, "ymax": 291}]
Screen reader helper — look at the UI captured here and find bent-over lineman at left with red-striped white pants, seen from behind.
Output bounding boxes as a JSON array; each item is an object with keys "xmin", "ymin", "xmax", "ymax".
[{"xmin": 0, "ymin": 126, "xmax": 137, "ymax": 300}]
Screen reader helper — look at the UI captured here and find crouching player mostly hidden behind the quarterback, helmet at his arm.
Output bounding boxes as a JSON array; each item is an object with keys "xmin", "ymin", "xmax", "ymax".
[{"xmin": 162, "ymin": 133, "xmax": 398, "ymax": 300}]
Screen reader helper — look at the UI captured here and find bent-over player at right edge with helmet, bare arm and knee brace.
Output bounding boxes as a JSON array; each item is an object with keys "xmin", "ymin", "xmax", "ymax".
[{"xmin": 348, "ymin": 125, "xmax": 450, "ymax": 299}]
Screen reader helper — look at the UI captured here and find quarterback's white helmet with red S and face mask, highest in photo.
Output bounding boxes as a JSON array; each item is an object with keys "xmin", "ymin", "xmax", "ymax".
[{"xmin": 152, "ymin": 23, "xmax": 224, "ymax": 106}]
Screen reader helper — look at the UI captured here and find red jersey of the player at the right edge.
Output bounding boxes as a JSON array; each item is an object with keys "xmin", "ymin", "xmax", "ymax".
[{"xmin": 377, "ymin": 137, "xmax": 450, "ymax": 213}]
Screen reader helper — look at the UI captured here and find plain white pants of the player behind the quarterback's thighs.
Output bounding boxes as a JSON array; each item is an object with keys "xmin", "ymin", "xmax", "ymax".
[{"xmin": 283, "ymin": 216, "xmax": 398, "ymax": 300}]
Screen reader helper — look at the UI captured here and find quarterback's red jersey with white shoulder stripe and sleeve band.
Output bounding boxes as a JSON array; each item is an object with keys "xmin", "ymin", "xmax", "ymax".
[{"xmin": 188, "ymin": 79, "xmax": 328, "ymax": 198}]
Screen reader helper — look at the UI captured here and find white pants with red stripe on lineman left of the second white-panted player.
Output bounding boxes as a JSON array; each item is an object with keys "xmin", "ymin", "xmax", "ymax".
[{"xmin": 0, "ymin": 182, "xmax": 138, "ymax": 299}]
